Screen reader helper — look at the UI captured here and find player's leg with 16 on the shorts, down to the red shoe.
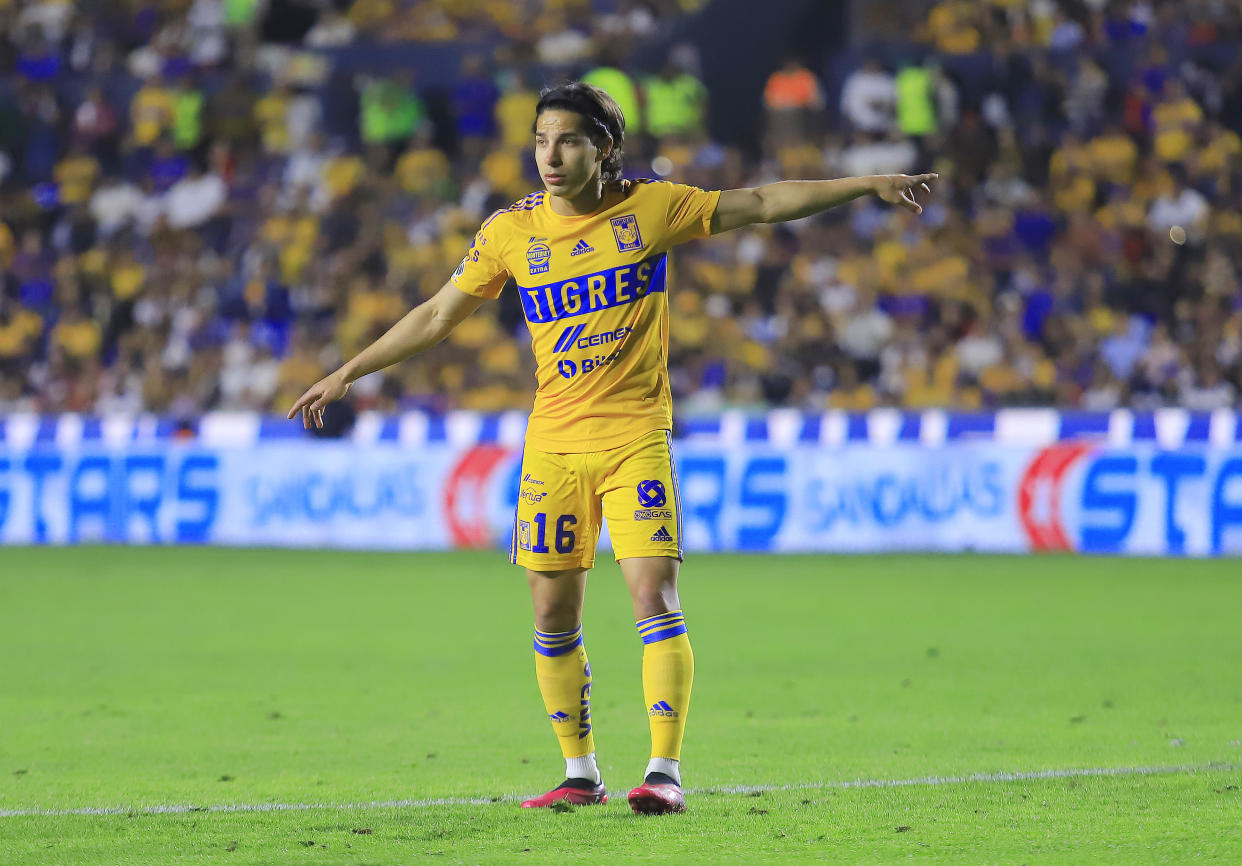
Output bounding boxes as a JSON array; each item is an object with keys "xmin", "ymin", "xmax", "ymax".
[{"xmin": 512, "ymin": 449, "xmax": 607, "ymax": 808}]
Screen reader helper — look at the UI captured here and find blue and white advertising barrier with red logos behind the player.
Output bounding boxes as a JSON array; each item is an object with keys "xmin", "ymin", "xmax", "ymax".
[{"xmin": 0, "ymin": 410, "xmax": 1242, "ymax": 555}]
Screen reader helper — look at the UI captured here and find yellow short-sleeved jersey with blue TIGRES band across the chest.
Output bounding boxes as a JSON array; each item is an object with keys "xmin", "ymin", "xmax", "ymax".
[{"xmin": 452, "ymin": 180, "xmax": 720, "ymax": 454}]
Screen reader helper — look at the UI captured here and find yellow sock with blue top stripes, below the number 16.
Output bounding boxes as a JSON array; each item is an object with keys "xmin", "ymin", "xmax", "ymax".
[{"xmin": 535, "ymin": 626, "xmax": 595, "ymax": 758}]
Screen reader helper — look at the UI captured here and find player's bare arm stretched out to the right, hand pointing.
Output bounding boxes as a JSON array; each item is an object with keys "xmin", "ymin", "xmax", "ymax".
[{"xmin": 712, "ymin": 174, "xmax": 939, "ymax": 235}]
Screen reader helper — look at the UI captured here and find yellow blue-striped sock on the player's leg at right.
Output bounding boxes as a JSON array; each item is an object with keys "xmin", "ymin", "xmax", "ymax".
[{"xmin": 636, "ymin": 610, "xmax": 694, "ymax": 760}]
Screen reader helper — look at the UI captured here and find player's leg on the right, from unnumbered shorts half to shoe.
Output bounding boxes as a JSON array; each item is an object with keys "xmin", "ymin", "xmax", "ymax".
[{"xmin": 602, "ymin": 431, "xmax": 694, "ymax": 813}]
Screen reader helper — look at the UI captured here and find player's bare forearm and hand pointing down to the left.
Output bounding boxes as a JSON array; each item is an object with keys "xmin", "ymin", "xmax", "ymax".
[{"xmin": 288, "ymin": 282, "xmax": 484, "ymax": 427}]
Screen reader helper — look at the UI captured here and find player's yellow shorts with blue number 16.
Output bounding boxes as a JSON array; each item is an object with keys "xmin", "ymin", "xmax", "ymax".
[{"xmin": 509, "ymin": 430, "xmax": 682, "ymax": 572}]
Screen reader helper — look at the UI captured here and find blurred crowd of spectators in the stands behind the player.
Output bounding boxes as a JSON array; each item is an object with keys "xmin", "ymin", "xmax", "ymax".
[{"xmin": 0, "ymin": 0, "xmax": 1242, "ymax": 416}]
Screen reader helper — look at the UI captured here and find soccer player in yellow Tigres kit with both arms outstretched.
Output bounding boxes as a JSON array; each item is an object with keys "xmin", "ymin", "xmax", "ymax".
[{"xmin": 289, "ymin": 82, "xmax": 936, "ymax": 814}]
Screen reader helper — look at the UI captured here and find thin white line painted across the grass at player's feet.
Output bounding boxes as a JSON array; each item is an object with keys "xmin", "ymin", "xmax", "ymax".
[{"xmin": 0, "ymin": 763, "xmax": 1242, "ymax": 818}]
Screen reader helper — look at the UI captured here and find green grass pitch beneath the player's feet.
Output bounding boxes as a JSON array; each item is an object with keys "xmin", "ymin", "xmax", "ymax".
[{"xmin": 0, "ymin": 548, "xmax": 1242, "ymax": 866}]
